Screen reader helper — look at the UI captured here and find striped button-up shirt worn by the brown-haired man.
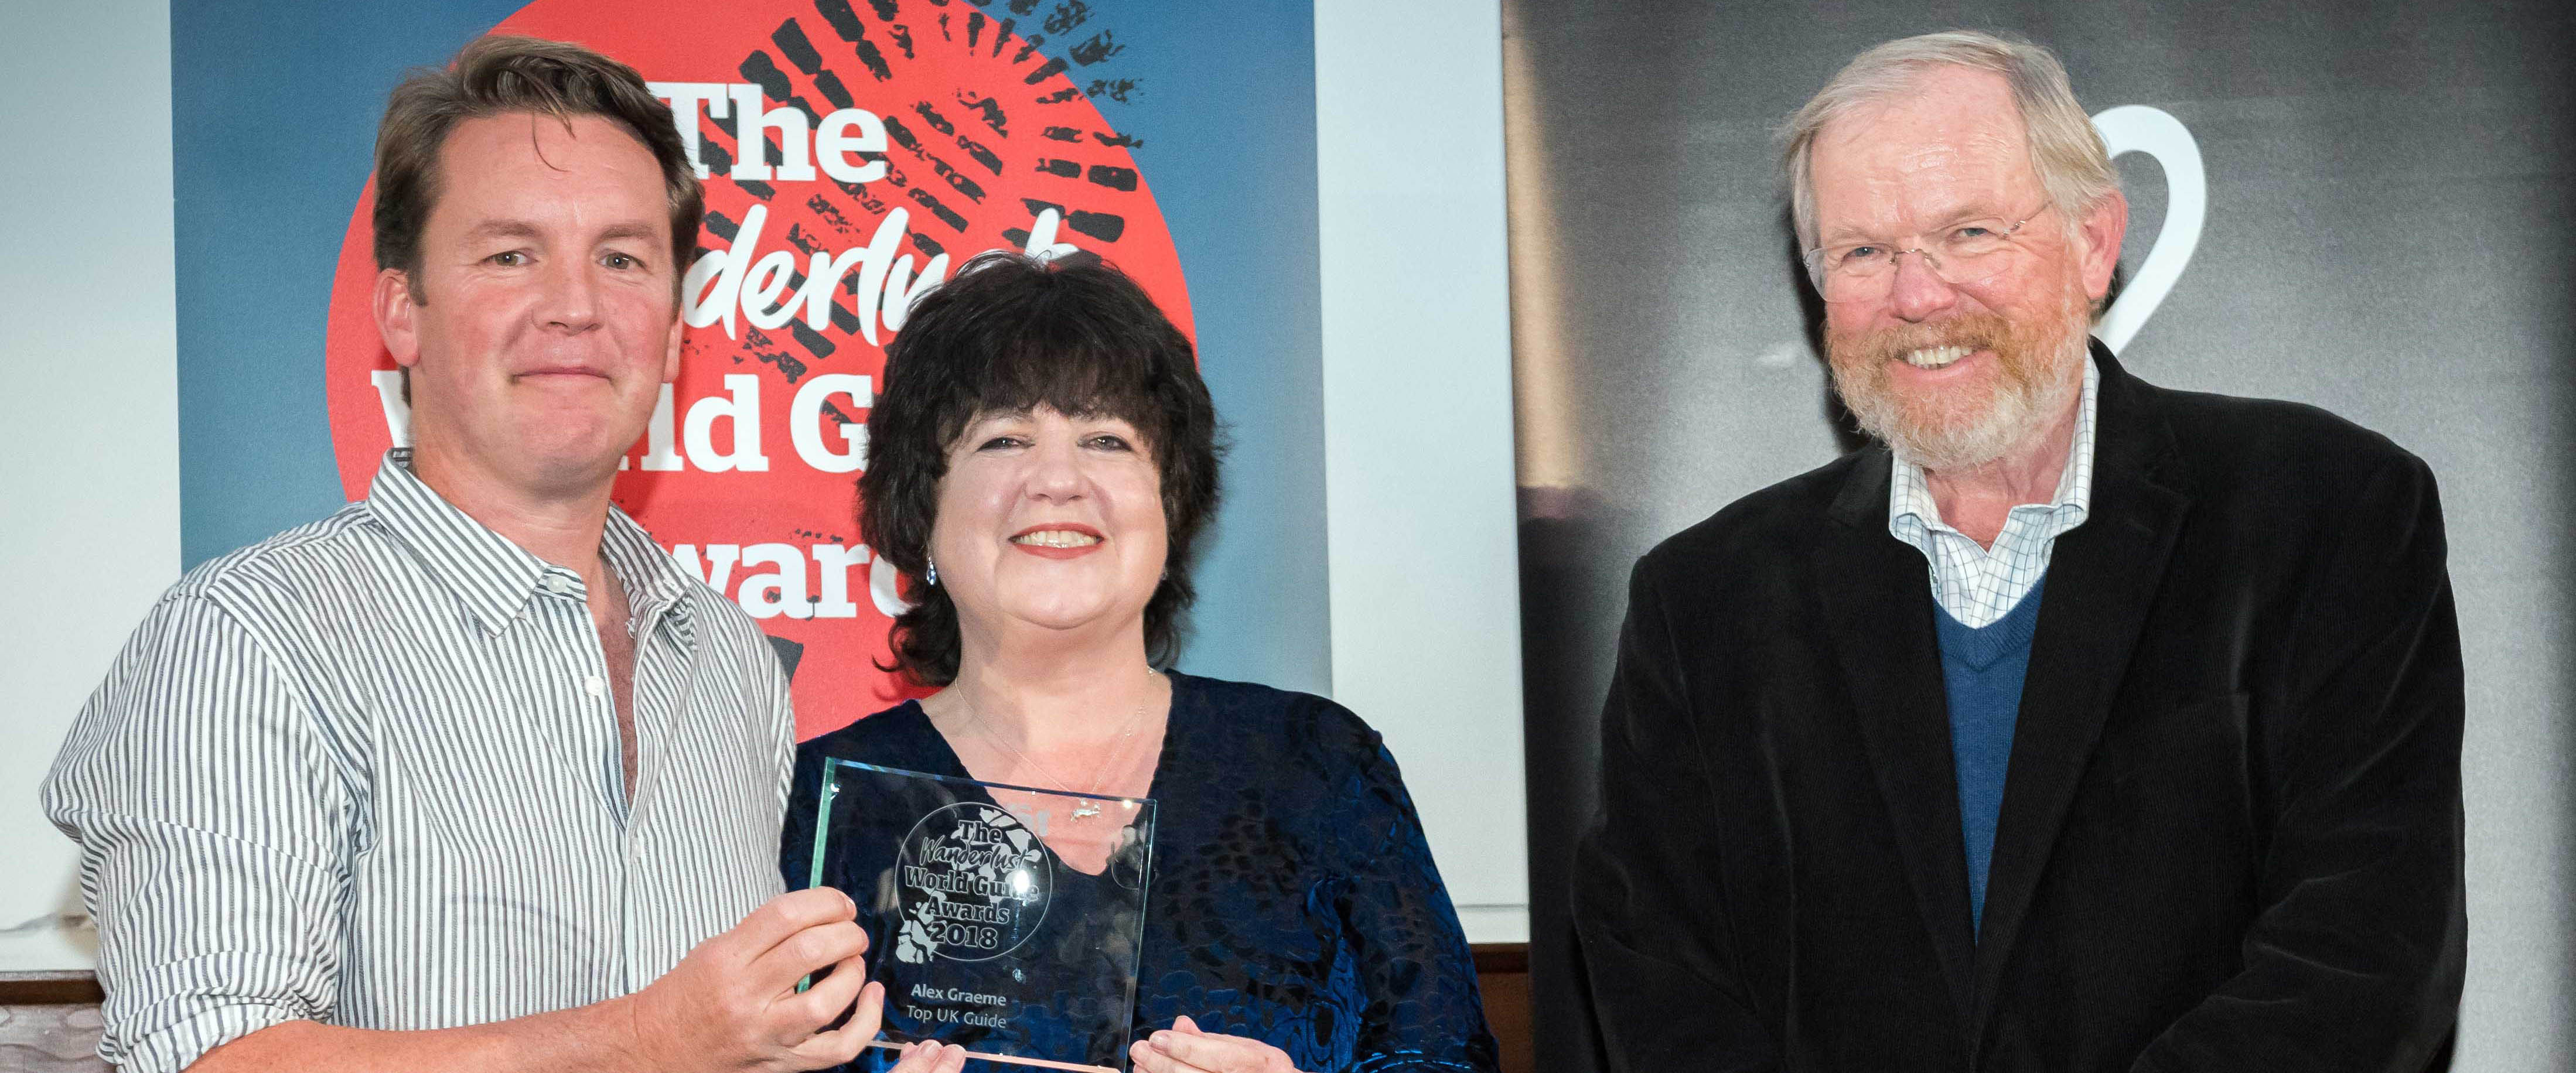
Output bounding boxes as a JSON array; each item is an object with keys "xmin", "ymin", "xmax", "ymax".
[{"xmin": 44, "ymin": 450, "xmax": 793, "ymax": 1071}]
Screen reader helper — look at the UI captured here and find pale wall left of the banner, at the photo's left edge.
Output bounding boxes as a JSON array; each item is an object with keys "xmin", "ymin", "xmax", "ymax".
[{"xmin": 0, "ymin": 0, "xmax": 178, "ymax": 973}]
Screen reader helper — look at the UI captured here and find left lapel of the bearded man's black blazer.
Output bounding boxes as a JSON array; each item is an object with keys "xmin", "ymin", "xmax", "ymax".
[{"xmin": 1811, "ymin": 447, "xmax": 1975, "ymax": 1032}]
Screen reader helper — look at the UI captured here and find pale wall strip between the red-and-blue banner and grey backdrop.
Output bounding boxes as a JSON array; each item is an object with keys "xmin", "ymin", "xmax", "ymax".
[{"xmin": 1313, "ymin": 0, "xmax": 1530, "ymax": 942}]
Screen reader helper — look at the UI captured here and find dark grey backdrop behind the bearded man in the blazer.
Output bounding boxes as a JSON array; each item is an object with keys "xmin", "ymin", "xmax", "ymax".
[{"xmin": 1504, "ymin": 0, "xmax": 2576, "ymax": 1071}]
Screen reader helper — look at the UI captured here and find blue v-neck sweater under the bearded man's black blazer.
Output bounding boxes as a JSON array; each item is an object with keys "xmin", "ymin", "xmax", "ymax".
[{"xmin": 1937, "ymin": 576, "xmax": 2048, "ymax": 929}]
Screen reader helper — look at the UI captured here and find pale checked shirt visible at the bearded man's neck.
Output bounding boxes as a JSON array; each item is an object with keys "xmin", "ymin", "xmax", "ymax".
[{"xmin": 1888, "ymin": 358, "xmax": 2102, "ymax": 628}]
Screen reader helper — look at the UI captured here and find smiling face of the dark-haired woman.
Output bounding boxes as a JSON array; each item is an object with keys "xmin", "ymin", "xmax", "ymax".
[{"xmin": 930, "ymin": 406, "xmax": 1167, "ymax": 646}]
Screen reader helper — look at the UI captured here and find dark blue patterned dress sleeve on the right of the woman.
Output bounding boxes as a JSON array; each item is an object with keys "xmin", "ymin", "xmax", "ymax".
[{"xmin": 1309, "ymin": 736, "xmax": 1499, "ymax": 1073}]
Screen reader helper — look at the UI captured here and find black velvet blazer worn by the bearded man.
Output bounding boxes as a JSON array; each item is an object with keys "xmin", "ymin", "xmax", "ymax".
[{"xmin": 1574, "ymin": 345, "xmax": 2468, "ymax": 1073}]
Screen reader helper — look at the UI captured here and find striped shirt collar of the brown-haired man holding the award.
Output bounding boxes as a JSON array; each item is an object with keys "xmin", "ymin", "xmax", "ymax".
[{"xmin": 366, "ymin": 447, "xmax": 688, "ymax": 635}]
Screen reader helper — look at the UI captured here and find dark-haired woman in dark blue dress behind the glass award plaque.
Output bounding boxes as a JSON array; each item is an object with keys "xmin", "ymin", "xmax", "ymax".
[{"xmin": 783, "ymin": 255, "xmax": 1497, "ymax": 1073}]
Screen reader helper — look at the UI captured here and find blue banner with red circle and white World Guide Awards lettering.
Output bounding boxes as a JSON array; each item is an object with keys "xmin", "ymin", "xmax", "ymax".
[{"xmin": 173, "ymin": 0, "xmax": 1326, "ymax": 736}]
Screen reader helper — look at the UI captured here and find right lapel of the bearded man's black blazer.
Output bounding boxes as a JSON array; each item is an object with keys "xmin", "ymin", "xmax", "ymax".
[{"xmin": 1975, "ymin": 342, "xmax": 2189, "ymax": 1027}]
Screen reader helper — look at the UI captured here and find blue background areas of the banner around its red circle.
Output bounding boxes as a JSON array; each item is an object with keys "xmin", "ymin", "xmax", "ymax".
[{"xmin": 170, "ymin": 0, "xmax": 1332, "ymax": 692}]
